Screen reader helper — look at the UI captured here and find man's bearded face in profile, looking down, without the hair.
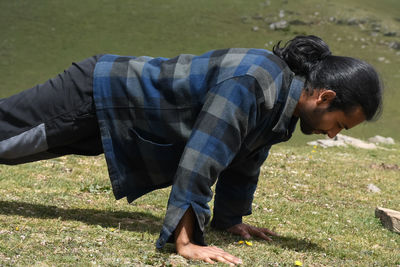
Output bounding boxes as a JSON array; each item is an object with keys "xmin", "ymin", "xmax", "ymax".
[{"xmin": 299, "ymin": 106, "xmax": 365, "ymax": 138}]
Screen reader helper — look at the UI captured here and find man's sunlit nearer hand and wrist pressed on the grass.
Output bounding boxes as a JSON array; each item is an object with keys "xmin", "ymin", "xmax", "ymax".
[{"xmin": 175, "ymin": 208, "xmax": 242, "ymax": 265}]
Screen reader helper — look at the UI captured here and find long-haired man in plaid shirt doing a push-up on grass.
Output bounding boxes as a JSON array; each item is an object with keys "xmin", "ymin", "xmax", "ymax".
[{"xmin": 0, "ymin": 36, "xmax": 382, "ymax": 264}]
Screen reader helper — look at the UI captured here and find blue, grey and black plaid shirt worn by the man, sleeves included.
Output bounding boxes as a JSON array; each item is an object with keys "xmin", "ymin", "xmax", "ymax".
[{"xmin": 94, "ymin": 48, "xmax": 304, "ymax": 248}]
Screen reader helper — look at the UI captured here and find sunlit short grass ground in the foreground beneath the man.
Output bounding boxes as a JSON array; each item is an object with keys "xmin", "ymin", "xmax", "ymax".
[{"xmin": 0, "ymin": 142, "xmax": 400, "ymax": 266}]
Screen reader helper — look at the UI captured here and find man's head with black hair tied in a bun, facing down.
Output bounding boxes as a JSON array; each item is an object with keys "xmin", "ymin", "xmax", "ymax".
[{"xmin": 273, "ymin": 36, "xmax": 383, "ymax": 137}]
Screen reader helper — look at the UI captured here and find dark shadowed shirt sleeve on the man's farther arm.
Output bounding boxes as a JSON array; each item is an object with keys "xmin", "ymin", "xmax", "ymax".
[{"xmin": 211, "ymin": 147, "xmax": 270, "ymax": 230}]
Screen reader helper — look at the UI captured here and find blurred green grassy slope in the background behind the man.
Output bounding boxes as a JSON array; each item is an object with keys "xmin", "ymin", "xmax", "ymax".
[{"xmin": 0, "ymin": 0, "xmax": 400, "ymax": 144}]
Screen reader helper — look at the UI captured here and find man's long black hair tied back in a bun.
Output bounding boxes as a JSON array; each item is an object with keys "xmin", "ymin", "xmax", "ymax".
[{"xmin": 273, "ymin": 35, "xmax": 383, "ymax": 121}]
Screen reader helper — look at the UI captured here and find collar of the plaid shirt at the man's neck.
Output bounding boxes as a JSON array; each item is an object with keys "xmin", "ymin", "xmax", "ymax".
[{"xmin": 272, "ymin": 76, "xmax": 305, "ymax": 132}]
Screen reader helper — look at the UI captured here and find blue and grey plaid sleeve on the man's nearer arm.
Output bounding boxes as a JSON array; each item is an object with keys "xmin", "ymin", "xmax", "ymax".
[{"xmin": 156, "ymin": 76, "xmax": 258, "ymax": 248}]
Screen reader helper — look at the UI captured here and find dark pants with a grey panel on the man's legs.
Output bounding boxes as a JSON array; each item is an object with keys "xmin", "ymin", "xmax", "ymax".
[{"xmin": 0, "ymin": 56, "xmax": 103, "ymax": 165}]
